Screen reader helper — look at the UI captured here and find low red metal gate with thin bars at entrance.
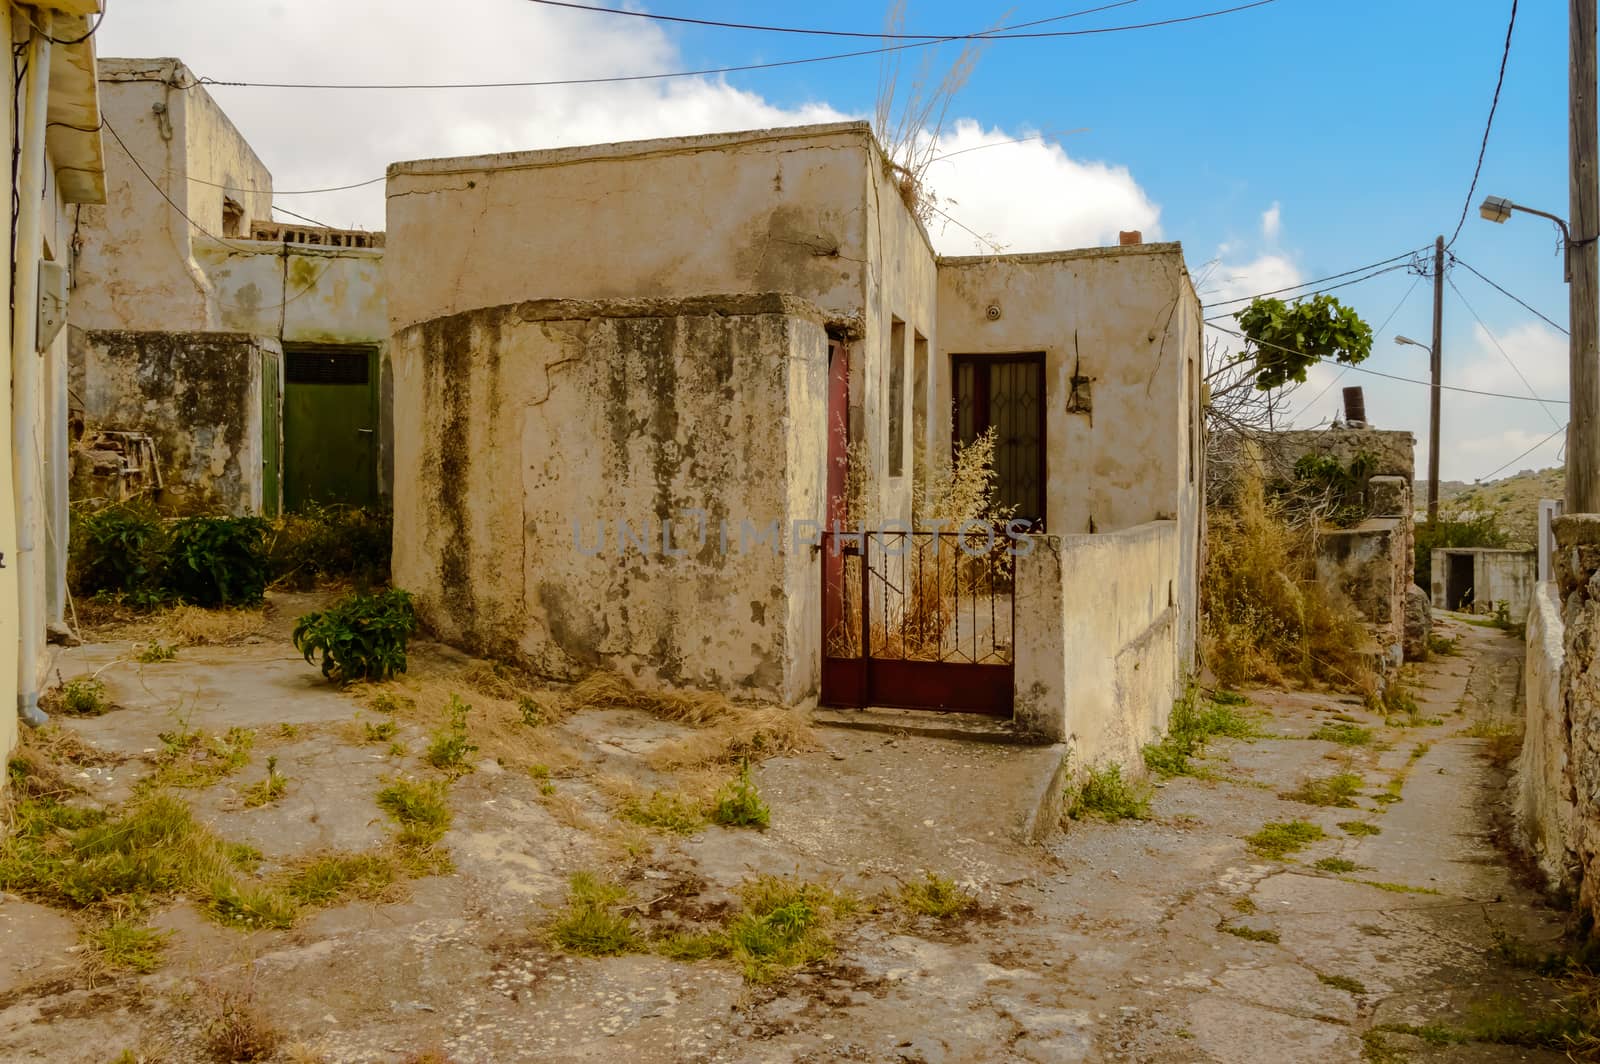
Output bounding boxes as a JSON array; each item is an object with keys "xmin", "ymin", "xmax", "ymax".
[{"xmin": 822, "ymin": 528, "xmax": 1016, "ymax": 717}]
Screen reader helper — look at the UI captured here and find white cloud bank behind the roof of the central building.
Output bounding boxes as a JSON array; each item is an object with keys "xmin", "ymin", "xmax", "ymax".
[{"xmin": 99, "ymin": 0, "xmax": 1160, "ymax": 253}]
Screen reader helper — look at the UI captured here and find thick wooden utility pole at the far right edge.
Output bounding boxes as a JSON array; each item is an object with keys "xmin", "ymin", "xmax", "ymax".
[{"xmin": 1566, "ymin": 0, "xmax": 1600, "ymax": 514}]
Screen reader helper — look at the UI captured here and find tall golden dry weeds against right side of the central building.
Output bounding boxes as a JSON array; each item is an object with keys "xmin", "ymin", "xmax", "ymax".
[{"xmin": 1200, "ymin": 472, "xmax": 1376, "ymax": 691}]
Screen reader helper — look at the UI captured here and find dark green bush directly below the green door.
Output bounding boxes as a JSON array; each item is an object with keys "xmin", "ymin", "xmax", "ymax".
[{"xmin": 269, "ymin": 502, "xmax": 394, "ymax": 589}]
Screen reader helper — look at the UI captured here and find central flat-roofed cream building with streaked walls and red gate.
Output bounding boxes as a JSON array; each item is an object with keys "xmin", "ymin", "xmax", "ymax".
[{"xmin": 386, "ymin": 123, "xmax": 1203, "ymax": 760}]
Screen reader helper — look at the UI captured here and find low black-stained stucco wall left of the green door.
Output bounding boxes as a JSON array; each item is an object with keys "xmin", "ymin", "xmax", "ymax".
[{"xmin": 72, "ymin": 330, "xmax": 270, "ymax": 514}]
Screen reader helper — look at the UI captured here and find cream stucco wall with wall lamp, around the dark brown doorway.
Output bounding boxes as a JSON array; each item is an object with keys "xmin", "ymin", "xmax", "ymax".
[{"xmin": 930, "ymin": 243, "xmax": 1205, "ymax": 670}]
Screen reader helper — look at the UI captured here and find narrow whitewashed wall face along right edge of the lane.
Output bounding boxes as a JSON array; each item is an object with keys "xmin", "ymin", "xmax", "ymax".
[{"xmin": 1514, "ymin": 581, "xmax": 1576, "ymax": 891}]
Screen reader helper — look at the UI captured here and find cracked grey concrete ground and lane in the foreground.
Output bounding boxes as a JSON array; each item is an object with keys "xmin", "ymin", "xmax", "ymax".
[{"xmin": 0, "ymin": 604, "xmax": 1566, "ymax": 1064}]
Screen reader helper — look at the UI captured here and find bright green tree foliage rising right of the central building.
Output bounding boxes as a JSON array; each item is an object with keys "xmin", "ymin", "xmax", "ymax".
[{"xmin": 1234, "ymin": 294, "xmax": 1373, "ymax": 390}]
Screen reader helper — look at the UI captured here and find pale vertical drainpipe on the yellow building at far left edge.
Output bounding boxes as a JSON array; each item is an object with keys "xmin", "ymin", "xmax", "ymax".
[{"xmin": 11, "ymin": 8, "xmax": 51, "ymax": 728}]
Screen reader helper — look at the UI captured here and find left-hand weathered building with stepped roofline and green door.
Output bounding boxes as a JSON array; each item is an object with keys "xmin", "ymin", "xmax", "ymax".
[{"xmin": 70, "ymin": 59, "xmax": 390, "ymax": 515}]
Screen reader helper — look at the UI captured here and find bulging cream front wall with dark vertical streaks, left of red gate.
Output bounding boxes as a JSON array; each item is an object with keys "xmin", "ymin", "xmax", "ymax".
[{"xmin": 394, "ymin": 296, "xmax": 827, "ymax": 702}]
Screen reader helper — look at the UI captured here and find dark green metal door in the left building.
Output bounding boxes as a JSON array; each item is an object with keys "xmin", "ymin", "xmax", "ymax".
[{"xmin": 283, "ymin": 344, "xmax": 378, "ymax": 512}]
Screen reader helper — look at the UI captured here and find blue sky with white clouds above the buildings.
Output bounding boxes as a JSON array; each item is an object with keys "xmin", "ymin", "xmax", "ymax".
[{"xmin": 101, "ymin": 0, "xmax": 1566, "ymax": 480}]
